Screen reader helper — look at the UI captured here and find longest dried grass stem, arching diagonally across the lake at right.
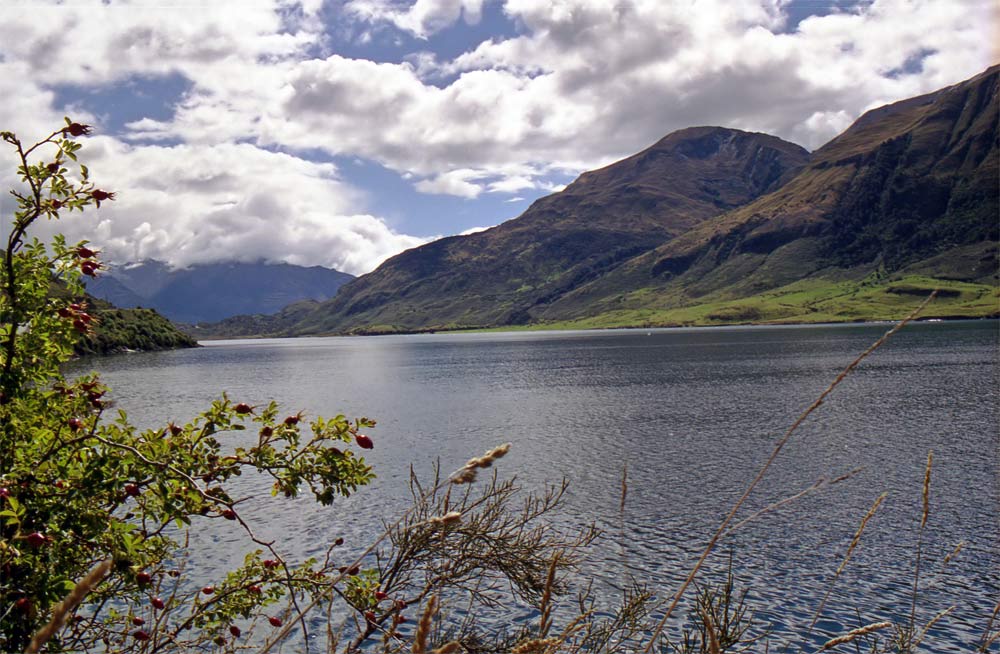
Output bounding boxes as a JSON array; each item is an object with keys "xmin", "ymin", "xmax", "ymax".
[{"xmin": 642, "ymin": 290, "xmax": 937, "ymax": 654}]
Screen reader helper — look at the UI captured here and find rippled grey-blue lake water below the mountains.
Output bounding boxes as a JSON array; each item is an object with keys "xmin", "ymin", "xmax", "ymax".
[{"xmin": 70, "ymin": 321, "xmax": 1000, "ymax": 652}]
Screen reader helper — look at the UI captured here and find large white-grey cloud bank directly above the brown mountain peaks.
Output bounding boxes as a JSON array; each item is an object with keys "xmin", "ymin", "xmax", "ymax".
[{"xmin": 143, "ymin": 0, "xmax": 993, "ymax": 190}]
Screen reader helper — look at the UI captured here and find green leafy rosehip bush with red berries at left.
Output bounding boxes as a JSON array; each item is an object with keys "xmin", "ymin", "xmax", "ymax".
[{"xmin": 0, "ymin": 119, "xmax": 374, "ymax": 651}]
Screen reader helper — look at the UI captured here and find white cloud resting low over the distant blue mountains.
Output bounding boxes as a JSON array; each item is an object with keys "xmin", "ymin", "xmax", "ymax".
[{"xmin": 26, "ymin": 137, "xmax": 425, "ymax": 274}]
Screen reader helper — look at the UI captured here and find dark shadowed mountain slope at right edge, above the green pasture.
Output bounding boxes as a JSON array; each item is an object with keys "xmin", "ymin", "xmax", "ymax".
[{"xmin": 536, "ymin": 67, "xmax": 1000, "ymax": 321}]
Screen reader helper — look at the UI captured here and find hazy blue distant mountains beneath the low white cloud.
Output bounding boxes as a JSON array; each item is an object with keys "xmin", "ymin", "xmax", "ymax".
[{"xmin": 87, "ymin": 261, "xmax": 354, "ymax": 324}]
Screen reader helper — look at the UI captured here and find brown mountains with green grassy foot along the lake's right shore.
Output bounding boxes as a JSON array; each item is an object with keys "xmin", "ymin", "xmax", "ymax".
[{"xmin": 195, "ymin": 66, "xmax": 1000, "ymax": 335}]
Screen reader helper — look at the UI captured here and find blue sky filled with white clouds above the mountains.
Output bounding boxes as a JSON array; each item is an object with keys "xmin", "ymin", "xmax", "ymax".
[{"xmin": 0, "ymin": 0, "xmax": 1000, "ymax": 275}]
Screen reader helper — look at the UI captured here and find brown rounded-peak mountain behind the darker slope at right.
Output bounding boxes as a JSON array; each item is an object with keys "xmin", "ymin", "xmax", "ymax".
[{"xmin": 295, "ymin": 127, "xmax": 808, "ymax": 333}]
